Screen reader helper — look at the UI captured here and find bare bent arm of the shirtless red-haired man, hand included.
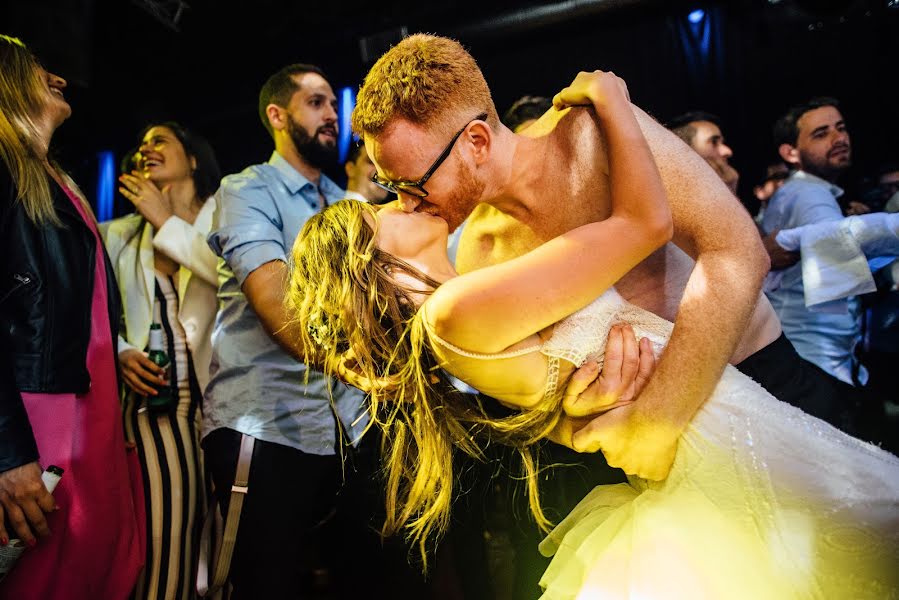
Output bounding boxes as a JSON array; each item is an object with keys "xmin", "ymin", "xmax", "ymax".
[{"xmin": 572, "ymin": 108, "xmax": 769, "ymax": 479}]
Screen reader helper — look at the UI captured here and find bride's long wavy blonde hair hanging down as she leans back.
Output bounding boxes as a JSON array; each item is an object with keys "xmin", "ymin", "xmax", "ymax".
[{"xmin": 287, "ymin": 200, "xmax": 560, "ymax": 569}]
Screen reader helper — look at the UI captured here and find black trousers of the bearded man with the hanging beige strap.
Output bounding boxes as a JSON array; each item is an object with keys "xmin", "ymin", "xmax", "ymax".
[{"xmin": 203, "ymin": 428, "xmax": 425, "ymax": 600}]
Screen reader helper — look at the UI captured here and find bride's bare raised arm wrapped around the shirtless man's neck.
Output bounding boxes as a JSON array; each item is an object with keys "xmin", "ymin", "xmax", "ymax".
[{"xmin": 425, "ymin": 71, "xmax": 672, "ymax": 353}]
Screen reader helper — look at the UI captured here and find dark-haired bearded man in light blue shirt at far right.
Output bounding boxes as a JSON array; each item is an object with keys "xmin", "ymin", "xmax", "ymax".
[{"xmin": 762, "ymin": 98, "xmax": 867, "ymax": 395}]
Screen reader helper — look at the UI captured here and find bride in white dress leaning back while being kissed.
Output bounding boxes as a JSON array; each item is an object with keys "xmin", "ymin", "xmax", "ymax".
[{"xmin": 287, "ymin": 73, "xmax": 899, "ymax": 599}]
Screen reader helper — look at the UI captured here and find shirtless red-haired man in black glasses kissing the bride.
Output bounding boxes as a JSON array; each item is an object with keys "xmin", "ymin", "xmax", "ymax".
[{"xmin": 353, "ymin": 34, "xmax": 798, "ymax": 479}]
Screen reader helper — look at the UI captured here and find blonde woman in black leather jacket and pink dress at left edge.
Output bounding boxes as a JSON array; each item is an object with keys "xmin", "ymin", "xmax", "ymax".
[{"xmin": 0, "ymin": 36, "xmax": 143, "ymax": 599}]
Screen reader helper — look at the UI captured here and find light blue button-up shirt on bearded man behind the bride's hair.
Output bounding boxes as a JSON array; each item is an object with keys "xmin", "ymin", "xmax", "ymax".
[{"xmin": 203, "ymin": 152, "xmax": 368, "ymax": 455}]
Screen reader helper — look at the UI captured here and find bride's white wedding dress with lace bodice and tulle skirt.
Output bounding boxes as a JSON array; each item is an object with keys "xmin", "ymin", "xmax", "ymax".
[{"xmin": 528, "ymin": 290, "xmax": 899, "ymax": 600}]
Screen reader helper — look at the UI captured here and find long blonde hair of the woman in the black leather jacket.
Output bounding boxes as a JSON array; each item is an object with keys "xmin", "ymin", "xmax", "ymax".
[{"xmin": 0, "ymin": 35, "xmax": 93, "ymax": 225}]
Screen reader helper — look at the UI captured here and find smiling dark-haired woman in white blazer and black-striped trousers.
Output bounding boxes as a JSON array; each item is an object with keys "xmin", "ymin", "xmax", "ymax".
[{"xmin": 102, "ymin": 121, "xmax": 220, "ymax": 599}]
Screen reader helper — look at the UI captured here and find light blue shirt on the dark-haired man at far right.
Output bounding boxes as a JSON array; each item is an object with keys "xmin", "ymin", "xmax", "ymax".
[{"xmin": 762, "ymin": 171, "xmax": 868, "ymax": 384}]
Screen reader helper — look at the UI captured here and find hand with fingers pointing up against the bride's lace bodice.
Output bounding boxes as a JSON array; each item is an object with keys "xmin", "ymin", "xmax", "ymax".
[{"xmin": 549, "ymin": 325, "xmax": 655, "ymax": 449}]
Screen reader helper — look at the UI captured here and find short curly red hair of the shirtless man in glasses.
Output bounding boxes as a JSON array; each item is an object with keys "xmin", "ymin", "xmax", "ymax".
[{"xmin": 352, "ymin": 33, "xmax": 499, "ymax": 137}]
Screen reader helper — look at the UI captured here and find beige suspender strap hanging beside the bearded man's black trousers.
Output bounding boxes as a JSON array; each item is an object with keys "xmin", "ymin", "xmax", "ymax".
[{"xmin": 197, "ymin": 434, "xmax": 256, "ymax": 597}]
